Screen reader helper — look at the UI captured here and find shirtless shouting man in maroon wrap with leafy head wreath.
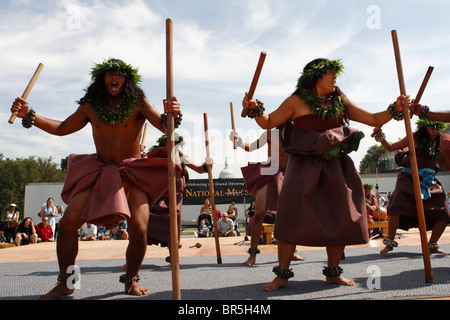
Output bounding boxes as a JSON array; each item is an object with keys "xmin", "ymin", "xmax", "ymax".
[{"xmin": 11, "ymin": 59, "xmax": 181, "ymax": 299}]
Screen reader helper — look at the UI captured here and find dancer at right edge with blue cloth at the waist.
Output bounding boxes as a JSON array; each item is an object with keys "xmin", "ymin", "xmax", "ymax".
[{"xmin": 374, "ymin": 119, "xmax": 450, "ymax": 255}]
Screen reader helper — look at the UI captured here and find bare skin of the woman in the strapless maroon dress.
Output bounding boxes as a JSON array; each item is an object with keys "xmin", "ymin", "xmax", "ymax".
[{"xmin": 242, "ymin": 70, "xmax": 411, "ymax": 291}]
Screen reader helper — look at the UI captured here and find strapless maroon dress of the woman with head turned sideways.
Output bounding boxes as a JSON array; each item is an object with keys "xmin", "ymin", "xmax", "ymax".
[{"xmin": 274, "ymin": 126, "xmax": 369, "ymax": 247}]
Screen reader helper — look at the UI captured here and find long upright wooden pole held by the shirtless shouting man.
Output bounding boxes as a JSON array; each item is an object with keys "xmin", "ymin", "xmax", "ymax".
[{"xmin": 166, "ymin": 19, "xmax": 181, "ymax": 300}]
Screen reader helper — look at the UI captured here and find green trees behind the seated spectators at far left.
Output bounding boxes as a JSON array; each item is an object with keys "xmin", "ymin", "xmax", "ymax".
[{"xmin": 0, "ymin": 153, "xmax": 66, "ymax": 218}]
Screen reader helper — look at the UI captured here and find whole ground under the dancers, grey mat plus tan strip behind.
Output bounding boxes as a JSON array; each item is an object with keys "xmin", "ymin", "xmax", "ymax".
[{"xmin": 0, "ymin": 230, "xmax": 450, "ymax": 302}]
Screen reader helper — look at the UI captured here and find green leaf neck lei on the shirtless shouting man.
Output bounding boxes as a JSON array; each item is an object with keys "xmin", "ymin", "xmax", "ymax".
[{"xmin": 89, "ymin": 94, "xmax": 143, "ymax": 125}]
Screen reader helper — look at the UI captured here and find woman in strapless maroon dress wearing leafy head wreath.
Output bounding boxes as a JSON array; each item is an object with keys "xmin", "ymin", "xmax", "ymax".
[{"xmin": 243, "ymin": 59, "xmax": 410, "ymax": 291}]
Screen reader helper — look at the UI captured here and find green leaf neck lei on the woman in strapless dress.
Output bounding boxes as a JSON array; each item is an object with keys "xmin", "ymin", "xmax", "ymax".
[{"xmin": 296, "ymin": 88, "xmax": 347, "ymax": 120}]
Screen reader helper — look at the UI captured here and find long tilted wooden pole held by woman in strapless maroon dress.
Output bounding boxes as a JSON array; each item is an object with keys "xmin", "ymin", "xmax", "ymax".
[{"xmin": 392, "ymin": 30, "xmax": 434, "ymax": 283}]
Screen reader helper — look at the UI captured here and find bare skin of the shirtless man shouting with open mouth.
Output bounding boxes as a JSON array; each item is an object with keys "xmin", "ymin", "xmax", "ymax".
[{"xmin": 11, "ymin": 73, "xmax": 180, "ymax": 300}]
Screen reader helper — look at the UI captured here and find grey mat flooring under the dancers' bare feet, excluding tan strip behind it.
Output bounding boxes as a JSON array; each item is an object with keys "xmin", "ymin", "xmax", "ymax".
[{"xmin": 0, "ymin": 244, "xmax": 450, "ymax": 301}]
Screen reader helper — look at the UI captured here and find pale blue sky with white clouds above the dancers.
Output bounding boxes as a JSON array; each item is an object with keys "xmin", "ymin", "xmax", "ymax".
[{"xmin": 0, "ymin": 0, "xmax": 450, "ymax": 178}]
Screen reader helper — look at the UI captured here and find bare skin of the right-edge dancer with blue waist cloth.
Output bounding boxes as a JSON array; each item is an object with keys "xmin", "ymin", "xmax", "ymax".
[{"xmin": 373, "ymin": 126, "xmax": 450, "ymax": 255}]
